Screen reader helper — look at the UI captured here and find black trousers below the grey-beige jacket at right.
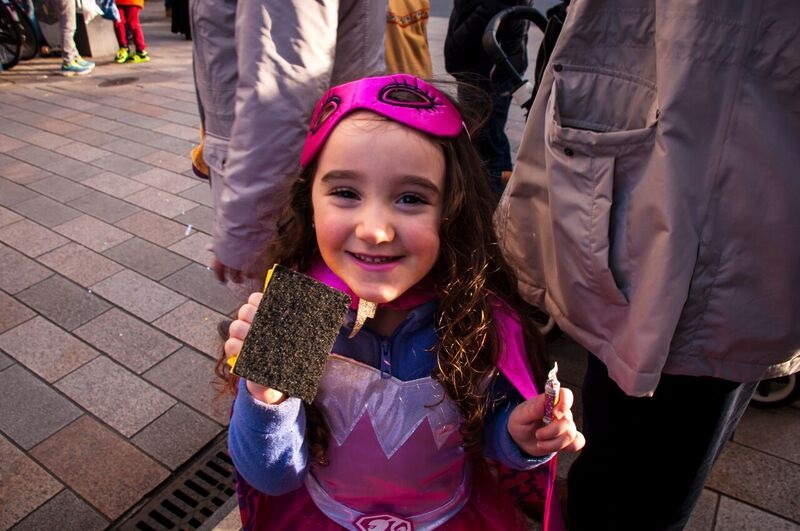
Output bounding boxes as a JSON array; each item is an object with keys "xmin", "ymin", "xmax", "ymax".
[{"xmin": 568, "ymin": 354, "xmax": 757, "ymax": 531}]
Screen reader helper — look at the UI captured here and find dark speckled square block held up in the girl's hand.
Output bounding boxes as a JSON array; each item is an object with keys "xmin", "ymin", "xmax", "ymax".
[{"xmin": 231, "ymin": 264, "xmax": 350, "ymax": 403}]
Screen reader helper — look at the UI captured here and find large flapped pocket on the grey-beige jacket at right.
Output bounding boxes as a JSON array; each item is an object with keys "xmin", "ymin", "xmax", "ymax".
[{"xmin": 545, "ymin": 64, "xmax": 658, "ymax": 314}]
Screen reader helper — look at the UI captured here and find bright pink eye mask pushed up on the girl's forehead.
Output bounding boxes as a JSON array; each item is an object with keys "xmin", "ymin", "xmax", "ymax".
[{"xmin": 300, "ymin": 74, "xmax": 466, "ymax": 168}]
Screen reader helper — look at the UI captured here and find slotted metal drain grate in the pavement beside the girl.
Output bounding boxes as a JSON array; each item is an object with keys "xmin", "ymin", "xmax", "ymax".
[{"xmin": 113, "ymin": 437, "xmax": 236, "ymax": 531}]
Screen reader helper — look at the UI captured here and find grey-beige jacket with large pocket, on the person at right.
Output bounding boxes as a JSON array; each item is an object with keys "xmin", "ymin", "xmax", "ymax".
[{"xmin": 496, "ymin": 0, "xmax": 800, "ymax": 396}]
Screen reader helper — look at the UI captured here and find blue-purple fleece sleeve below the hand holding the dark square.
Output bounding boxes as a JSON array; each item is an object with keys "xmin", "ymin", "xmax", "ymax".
[{"xmin": 228, "ymin": 379, "xmax": 308, "ymax": 496}]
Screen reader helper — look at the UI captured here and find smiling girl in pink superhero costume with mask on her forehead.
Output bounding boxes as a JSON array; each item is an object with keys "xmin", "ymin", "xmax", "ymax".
[{"xmin": 219, "ymin": 74, "xmax": 584, "ymax": 531}]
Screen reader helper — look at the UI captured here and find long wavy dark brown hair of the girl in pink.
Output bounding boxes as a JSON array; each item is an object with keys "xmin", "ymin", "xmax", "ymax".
[{"xmin": 218, "ymin": 91, "xmax": 545, "ymax": 464}]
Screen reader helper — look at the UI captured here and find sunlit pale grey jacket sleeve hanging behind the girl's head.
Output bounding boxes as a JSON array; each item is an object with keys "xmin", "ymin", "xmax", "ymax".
[{"xmin": 213, "ymin": 0, "xmax": 386, "ymax": 272}]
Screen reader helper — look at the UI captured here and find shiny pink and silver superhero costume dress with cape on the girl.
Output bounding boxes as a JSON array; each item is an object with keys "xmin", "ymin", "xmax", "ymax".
[{"xmin": 232, "ymin": 266, "xmax": 563, "ymax": 531}]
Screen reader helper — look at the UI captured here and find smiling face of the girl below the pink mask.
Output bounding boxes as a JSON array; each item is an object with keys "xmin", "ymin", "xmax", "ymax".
[{"xmin": 311, "ymin": 112, "xmax": 445, "ymax": 303}]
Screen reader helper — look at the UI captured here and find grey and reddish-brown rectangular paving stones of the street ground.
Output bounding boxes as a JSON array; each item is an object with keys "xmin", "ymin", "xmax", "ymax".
[{"xmin": 0, "ymin": 0, "xmax": 800, "ymax": 531}]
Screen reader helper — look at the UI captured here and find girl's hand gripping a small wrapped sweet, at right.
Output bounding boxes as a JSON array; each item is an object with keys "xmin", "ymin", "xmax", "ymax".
[{"xmin": 508, "ymin": 387, "xmax": 586, "ymax": 456}]
